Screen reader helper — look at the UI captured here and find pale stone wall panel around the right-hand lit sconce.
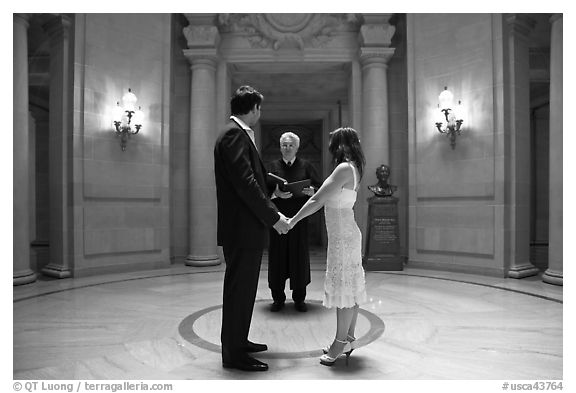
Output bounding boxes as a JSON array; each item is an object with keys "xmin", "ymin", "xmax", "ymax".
[{"xmin": 407, "ymin": 14, "xmax": 505, "ymax": 275}]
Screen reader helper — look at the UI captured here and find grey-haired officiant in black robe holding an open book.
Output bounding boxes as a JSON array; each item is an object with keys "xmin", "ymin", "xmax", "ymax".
[{"xmin": 268, "ymin": 132, "xmax": 322, "ymax": 312}]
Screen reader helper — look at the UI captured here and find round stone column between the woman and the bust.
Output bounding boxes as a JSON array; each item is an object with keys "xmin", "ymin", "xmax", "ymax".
[{"xmin": 356, "ymin": 14, "xmax": 395, "ymax": 247}]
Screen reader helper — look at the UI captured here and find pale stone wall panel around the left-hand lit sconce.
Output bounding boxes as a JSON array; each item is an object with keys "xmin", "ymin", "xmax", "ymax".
[{"xmin": 71, "ymin": 14, "xmax": 171, "ymax": 276}]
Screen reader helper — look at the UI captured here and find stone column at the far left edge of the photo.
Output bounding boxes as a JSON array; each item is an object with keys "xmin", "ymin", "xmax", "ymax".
[{"xmin": 12, "ymin": 14, "xmax": 36, "ymax": 285}]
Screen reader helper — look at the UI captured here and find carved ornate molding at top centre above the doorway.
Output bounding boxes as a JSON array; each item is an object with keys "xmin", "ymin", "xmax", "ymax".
[{"xmin": 218, "ymin": 14, "xmax": 359, "ymax": 50}]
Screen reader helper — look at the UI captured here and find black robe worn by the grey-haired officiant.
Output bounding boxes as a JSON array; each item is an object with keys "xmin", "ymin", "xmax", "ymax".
[{"xmin": 268, "ymin": 157, "xmax": 322, "ymax": 290}]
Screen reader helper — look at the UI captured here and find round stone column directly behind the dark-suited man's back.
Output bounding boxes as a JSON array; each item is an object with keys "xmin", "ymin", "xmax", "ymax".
[{"xmin": 184, "ymin": 14, "xmax": 220, "ymax": 266}]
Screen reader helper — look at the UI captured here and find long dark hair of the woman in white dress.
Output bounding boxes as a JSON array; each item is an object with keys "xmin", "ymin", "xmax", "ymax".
[{"xmin": 328, "ymin": 127, "xmax": 366, "ymax": 178}]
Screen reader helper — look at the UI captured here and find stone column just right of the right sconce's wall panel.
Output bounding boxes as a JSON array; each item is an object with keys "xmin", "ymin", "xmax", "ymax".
[{"xmin": 505, "ymin": 14, "xmax": 538, "ymax": 278}]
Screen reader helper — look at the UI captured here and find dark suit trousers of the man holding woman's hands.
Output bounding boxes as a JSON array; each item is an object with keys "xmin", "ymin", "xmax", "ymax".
[{"xmin": 220, "ymin": 247, "xmax": 263, "ymax": 361}]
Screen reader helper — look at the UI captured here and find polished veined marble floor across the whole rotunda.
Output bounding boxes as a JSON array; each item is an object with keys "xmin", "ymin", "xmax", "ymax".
[{"xmin": 13, "ymin": 256, "xmax": 563, "ymax": 380}]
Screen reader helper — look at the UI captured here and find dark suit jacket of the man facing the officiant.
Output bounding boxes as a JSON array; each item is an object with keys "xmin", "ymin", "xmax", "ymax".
[{"xmin": 214, "ymin": 121, "xmax": 280, "ymax": 248}]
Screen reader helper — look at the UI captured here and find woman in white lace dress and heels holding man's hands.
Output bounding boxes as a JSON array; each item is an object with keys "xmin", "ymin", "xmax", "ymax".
[{"xmin": 289, "ymin": 127, "xmax": 366, "ymax": 366}]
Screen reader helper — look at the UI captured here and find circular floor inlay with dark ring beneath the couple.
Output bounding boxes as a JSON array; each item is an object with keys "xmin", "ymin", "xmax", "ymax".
[{"xmin": 178, "ymin": 299, "xmax": 385, "ymax": 359}]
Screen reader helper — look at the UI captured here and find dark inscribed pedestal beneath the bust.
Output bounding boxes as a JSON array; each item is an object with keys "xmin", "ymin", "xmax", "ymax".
[{"xmin": 363, "ymin": 196, "xmax": 404, "ymax": 271}]
